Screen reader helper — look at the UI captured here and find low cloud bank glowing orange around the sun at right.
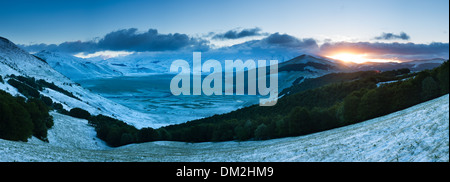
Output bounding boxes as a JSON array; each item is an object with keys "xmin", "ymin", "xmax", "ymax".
[{"xmin": 320, "ymin": 42, "xmax": 449, "ymax": 60}]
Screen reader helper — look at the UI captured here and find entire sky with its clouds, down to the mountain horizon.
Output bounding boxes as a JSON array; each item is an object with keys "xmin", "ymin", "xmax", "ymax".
[{"xmin": 0, "ymin": 0, "xmax": 449, "ymax": 61}]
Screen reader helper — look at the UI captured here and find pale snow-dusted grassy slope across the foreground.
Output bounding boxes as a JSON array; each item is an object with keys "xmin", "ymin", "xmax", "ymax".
[{"xmin": 0, "ymin": 94, "xmax": 449, "ymax": 162}]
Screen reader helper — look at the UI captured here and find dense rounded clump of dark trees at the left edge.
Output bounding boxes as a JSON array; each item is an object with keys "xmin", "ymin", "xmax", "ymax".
[{"xmin": 0, "ymin": 90, "xmax": 53, "ymax": 141}]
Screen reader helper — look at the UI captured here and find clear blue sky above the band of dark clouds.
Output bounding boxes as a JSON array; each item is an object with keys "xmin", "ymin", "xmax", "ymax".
[{"xmin": 0, "ymin": 0, "xmax": 449, "ymax": 44}]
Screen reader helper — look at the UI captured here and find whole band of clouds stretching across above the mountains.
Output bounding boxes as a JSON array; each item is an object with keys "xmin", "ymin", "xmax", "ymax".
[{"xmin": 21, "ymin": 28, "xmax": 449, "ymax": 60}]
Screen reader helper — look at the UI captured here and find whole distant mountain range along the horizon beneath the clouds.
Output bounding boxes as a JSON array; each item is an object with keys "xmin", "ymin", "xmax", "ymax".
[{"xmin": 29, "ymin": 48, "xmax": 445, "ymax": 83}]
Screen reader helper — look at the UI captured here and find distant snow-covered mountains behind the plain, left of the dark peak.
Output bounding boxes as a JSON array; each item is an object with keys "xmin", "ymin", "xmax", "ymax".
[{"xmin": 28, "ymin": 50, "xmax": 294, "ymax": 80}]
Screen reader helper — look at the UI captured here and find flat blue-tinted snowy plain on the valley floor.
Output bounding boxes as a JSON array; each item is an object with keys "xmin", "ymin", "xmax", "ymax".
[{"xmin": 79, "ymin": 74, "xmax": 259, "ymax": 125}]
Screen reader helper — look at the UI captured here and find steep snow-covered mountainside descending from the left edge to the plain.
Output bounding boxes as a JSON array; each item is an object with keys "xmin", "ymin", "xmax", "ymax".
[{"xmin": 0, "ymin": 37, "xmax": 159, "ymax": 128}]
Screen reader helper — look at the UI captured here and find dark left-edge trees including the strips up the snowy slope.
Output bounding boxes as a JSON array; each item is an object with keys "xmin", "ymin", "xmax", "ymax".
[{"xmin": 0, "ymin": 75, "xmax": 76, "ymax": 142}]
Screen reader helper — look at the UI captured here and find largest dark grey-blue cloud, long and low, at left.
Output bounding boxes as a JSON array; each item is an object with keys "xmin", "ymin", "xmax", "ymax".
[{"xmin": 22, "ymin": 28, "xmax": 209, "ymax": 53}]
